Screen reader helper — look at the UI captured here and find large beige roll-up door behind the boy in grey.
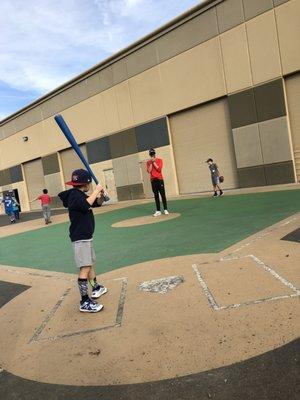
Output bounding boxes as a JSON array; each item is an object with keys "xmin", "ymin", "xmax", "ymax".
[{"xmin": 170, "ymin": 99, "xmax": 237, "ymax": 194}]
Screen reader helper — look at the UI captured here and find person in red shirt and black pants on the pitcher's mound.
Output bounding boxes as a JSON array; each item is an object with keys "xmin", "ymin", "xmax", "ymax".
[{"xmin": 147, "ymin": 149, "xmax": 169, "ymax": 217}]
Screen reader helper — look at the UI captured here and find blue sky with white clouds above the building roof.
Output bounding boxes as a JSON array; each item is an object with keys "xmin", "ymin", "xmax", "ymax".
[{"xmin": 0, "ymin": 0, "xmax": 201, "ymax": 120}]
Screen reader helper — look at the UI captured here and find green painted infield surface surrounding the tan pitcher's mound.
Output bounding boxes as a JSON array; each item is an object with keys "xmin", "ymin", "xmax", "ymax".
[{"xmin": 0, "ymin": 190, "xmax": 300, "ymax": 273}]
